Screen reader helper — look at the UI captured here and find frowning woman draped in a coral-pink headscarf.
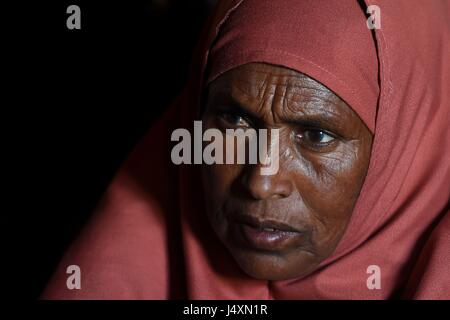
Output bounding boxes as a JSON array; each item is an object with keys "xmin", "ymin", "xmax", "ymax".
[{"xmin": 43, "ymin": 0, "xmax": 450, "ymax": 299}]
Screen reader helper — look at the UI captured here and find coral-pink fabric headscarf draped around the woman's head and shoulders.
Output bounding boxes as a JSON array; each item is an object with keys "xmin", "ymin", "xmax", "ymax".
[{"xmin": 43, "ymin": 0, "xmax": 450, "ymax": 299}]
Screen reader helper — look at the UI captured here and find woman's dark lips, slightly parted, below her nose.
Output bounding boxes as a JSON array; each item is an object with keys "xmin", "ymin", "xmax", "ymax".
[{"xmin": 231, "ymin": 215, "xmax": 305, "ymax": 251}]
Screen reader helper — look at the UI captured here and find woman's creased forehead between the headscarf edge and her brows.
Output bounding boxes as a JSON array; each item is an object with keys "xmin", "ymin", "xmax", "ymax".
[{"xmin": 209, "ymin": 63, "xmax": 352, "ymax": 118}]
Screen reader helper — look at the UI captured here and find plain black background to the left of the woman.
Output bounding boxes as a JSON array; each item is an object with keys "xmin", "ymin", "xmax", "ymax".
[{"xmin": 13, "ymin": 0, "xmax": 214, "ymax": 299}]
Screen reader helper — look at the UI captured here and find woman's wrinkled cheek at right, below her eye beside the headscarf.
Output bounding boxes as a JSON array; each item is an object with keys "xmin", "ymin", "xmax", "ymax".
[{"xmin": 296, "ymin": 141, "xmax": 367, "ymax": 243}]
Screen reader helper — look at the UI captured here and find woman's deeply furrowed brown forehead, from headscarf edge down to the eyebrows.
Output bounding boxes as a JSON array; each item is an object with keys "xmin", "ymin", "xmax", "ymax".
[{"xmin": 207, "ymin": 63, "xmax": 355, "ymax": 127}]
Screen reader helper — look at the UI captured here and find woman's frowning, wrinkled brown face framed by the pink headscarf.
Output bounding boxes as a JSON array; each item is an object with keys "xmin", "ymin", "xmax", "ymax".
[{"xmin": 202, "ymin": 63, "xmax": 372, "ymax": 280}]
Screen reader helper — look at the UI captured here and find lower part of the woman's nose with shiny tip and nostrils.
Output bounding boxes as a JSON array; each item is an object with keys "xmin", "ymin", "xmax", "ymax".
[{"xmin": 242, "ymin": 163, "xmax": 293, "ymax": 200}]
